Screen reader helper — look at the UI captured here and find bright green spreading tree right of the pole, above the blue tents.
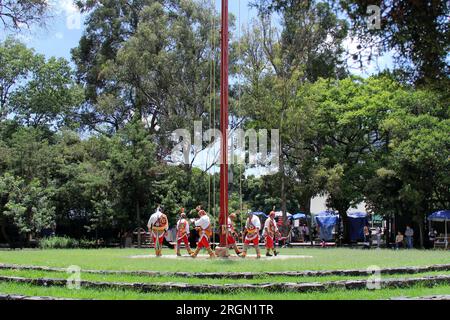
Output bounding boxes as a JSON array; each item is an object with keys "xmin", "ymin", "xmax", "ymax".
[{"xmin": 287, "ymin": 77, "xmax": 414, "ymax": 240}]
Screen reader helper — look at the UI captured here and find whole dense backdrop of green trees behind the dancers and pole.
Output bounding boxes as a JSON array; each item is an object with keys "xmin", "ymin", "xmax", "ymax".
[{"xmin": 0, "ymin": 0, "xmax": 450, "ymax": 246}]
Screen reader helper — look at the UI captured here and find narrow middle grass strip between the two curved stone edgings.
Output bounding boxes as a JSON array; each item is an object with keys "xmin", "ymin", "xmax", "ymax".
[{"xmin": 0, "ymin": 270, "xmax": 450, "ymax": 284}]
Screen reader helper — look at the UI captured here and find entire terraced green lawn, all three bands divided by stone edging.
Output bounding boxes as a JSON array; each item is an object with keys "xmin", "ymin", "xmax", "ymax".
[{"xmin": 0, "ymin": 248, "xmax": 450, "ymax": 300}]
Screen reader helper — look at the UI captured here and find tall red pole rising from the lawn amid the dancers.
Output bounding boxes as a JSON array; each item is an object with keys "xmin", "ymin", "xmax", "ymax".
[{"xmin": 216, "ymin": 0, "xmax": 228, "ymax": 256}]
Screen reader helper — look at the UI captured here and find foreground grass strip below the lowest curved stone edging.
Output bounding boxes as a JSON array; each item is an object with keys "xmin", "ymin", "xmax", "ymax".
[{"xmin": 0, "ymin": 283, "xmax": 450, "ymax": 300}]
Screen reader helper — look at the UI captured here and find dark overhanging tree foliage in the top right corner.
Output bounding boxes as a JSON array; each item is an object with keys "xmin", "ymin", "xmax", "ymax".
[{"xmin": 338, "ymin": 0, "xmax": 450, "ymax": 85}]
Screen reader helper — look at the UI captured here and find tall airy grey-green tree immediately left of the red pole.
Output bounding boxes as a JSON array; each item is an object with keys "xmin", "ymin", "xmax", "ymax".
[{"xmin": 73, "ymin": 0, "xmax": 219, "ymax": 159}]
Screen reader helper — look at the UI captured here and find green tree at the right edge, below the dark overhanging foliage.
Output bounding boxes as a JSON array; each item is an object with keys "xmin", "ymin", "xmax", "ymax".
[{"xmin": 375, "ymin": 89, "xmax": 450, "ymax": 246}]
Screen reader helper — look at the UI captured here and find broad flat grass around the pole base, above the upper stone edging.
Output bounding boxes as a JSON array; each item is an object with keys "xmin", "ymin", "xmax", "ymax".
[{"xmin": 0, "ymin": 248, "xmax": 450, "ymax": 272}]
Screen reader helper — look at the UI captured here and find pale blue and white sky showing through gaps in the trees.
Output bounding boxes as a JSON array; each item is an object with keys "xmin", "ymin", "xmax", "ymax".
[{"xmin": 0, "ymin": 0, "xmax": 393, "ymax": 212}]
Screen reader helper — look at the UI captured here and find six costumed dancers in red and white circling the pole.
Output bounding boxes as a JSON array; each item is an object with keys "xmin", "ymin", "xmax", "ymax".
[{"xmin": 148, "ymin": 206, "xmax": 280, "ymax": 259}]
